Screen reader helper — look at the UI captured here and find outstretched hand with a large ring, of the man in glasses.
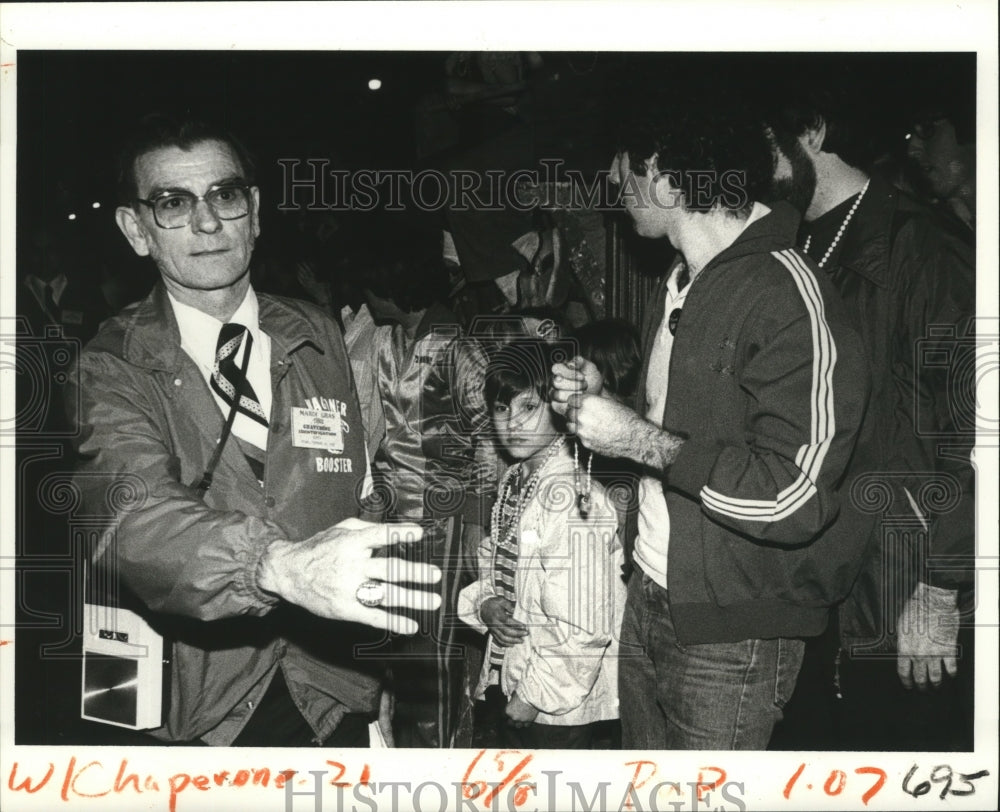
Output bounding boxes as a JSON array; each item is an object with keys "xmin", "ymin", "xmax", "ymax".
[{"xmin": 257, "ymin": 519, "xmax": 441, "ymax": 634}]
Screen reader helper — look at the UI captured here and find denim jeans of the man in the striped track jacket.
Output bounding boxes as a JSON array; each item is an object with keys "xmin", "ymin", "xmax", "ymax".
[{"xmin": 618, "ymin": 568, "xmax": 805, "ymax": 750}]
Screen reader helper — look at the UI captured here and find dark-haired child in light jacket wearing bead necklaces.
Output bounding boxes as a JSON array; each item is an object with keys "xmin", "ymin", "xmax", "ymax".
[{"xmin": 458, "ymin": 339, "xmax": 625, "ymax": 749}]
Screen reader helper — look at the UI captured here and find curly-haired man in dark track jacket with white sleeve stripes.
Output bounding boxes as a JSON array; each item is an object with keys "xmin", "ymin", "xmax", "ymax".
[{"xmin": 555, "ymin": 108, "xmax": 870, "ymax": 750}]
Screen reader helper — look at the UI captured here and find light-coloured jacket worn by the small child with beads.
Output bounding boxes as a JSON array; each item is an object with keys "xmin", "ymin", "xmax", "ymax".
[{"xmin": 458, "ymin": 450, "xmax": 625, "ymax": 725}]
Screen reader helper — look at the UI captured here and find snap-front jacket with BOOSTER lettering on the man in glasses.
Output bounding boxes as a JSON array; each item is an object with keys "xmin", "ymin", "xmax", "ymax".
[{"xmin": 67, "ymin": 285, "xmax": 379, "ymax": 745}]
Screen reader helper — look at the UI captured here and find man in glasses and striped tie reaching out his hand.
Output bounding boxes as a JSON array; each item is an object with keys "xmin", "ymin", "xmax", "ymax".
[{"xmin": 69, "ymin": 116, "xmax": 440, "ymax": 746}]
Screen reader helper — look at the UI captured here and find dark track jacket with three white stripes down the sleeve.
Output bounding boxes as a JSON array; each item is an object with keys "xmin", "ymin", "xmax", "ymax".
[{"xmin": 630, "ymin": 203, "xmax": 871, "ymax": 644}]
